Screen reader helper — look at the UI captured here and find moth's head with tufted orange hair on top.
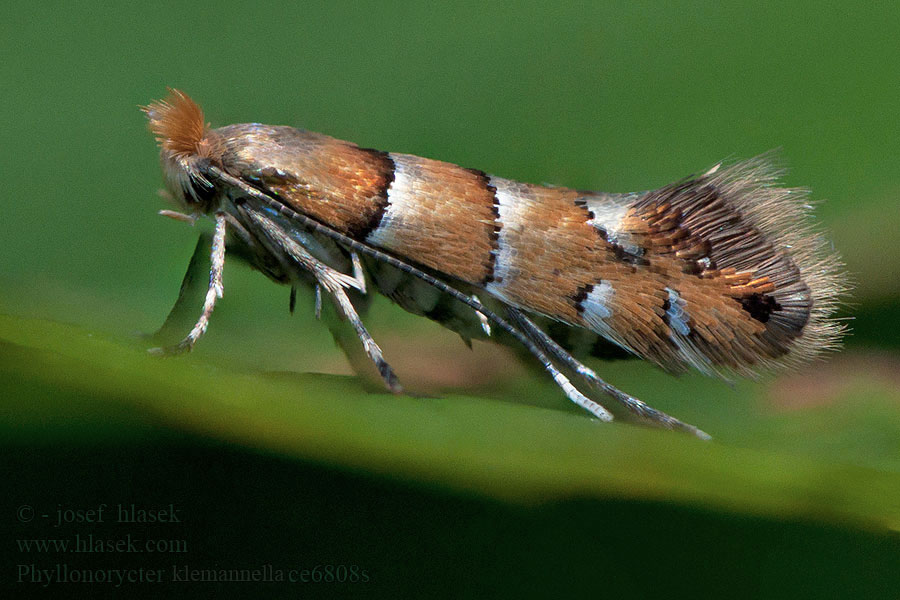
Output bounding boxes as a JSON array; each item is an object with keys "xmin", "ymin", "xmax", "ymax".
[{"xmin": 141, "ymin": 88, "xmax": 223, "ymax": 213}]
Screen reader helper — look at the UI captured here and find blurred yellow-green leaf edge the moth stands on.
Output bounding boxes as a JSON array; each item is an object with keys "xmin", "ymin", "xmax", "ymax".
[{"xmin": 0, "ymin": 316, "xmax": 900, "ymax": 530}]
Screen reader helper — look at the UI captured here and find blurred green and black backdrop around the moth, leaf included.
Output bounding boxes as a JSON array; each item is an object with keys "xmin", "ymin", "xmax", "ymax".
[{"xmin": 0, "ymin": 1, "xmax": 900, "ymax": 598}]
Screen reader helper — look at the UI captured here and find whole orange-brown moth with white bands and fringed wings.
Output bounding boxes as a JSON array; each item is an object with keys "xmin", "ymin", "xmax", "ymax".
[{"xmin": 142, "ymin": 90, "xmax": 845, "ymax": 438}]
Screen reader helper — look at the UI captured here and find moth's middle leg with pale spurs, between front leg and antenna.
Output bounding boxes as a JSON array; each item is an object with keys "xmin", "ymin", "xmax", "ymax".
[{"xmin": 242, "ymin": 207, "xmax": 403, "ymax": 393}]
